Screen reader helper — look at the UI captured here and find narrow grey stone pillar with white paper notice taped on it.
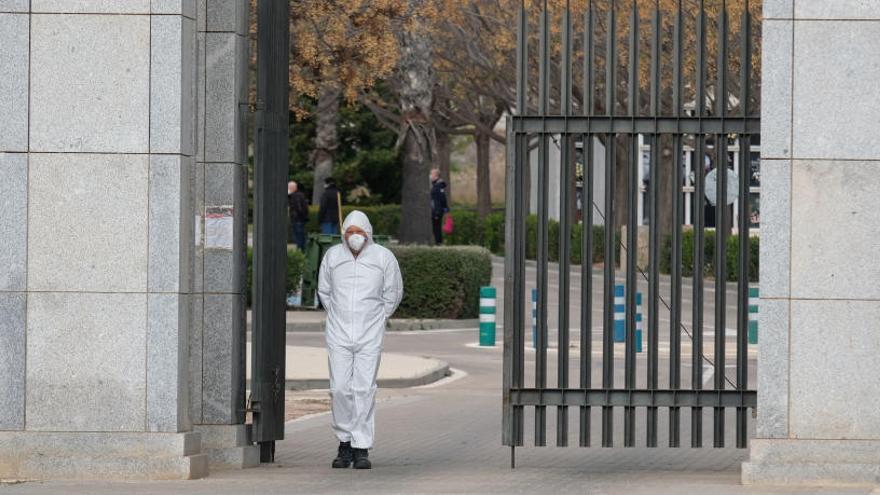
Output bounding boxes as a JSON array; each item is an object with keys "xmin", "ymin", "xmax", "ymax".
[{"xmin": 190, "ymin": 0, "xmax": 259, "ymax": 468}]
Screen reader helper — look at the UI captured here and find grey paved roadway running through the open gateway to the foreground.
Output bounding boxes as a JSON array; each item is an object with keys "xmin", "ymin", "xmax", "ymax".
[{"xmin": 0, "ymin": 330, "xmax": 880, "ymax": 495}]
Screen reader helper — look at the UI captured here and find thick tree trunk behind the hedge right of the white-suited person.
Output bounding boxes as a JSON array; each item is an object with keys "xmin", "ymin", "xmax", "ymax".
[{"xmin": 396, "ymin": 14, "xmax": 436, "ymax": 244}]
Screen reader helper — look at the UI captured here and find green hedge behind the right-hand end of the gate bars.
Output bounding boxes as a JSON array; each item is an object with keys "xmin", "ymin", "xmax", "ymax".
[{"xmin": 660, "ymin": 230, "xmax": 760, "ymax": 282}]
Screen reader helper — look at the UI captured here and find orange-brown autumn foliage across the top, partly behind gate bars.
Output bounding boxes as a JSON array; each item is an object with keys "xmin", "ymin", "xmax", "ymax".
[{"xmin": 278, "ymin": 0, "xmax": 761, "ymax": 113}]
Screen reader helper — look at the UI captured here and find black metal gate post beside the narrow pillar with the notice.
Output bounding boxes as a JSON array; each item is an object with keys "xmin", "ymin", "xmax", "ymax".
[{"xmin": 251, "ymin": 0, "xmax": 290, "ymax": 462}]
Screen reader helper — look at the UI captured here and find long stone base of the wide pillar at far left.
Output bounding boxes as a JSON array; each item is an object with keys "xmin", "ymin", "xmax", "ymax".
[{"xmin": 0, "ymin": 431, "xmax": 208, "ymax": 480}]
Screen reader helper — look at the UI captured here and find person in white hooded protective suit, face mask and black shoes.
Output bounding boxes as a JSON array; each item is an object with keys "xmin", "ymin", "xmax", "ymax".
[{"xmin": 318, "ymin": 211, "xmax": 403, "ymax": 469}]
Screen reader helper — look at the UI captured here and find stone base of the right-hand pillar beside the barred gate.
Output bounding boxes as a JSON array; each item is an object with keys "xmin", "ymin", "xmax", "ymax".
[{"xmin": 742, "ymin": 439, "xmax": 880, "ymax": 485}]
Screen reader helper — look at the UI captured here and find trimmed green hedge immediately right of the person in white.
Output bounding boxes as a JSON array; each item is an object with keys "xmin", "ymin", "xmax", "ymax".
[{"xmin": 392, "ymin": 246, "xmax": 492, "ymax": 319}]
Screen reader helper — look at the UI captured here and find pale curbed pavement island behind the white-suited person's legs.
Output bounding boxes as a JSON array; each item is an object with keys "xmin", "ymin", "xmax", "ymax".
[{"xmin": 246, "ymin": 342, "xmax": 449, "ymax": 390}]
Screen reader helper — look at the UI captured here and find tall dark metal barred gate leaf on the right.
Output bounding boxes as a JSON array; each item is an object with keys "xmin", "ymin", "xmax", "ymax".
[{"xmin": 502, "ymin": 0, "xmax": 760, "ymax": 467}]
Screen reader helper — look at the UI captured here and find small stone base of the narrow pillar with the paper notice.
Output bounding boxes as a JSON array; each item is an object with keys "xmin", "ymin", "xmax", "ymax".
[{"xmin": 193, "ymin": 425, "xmax": 260, "ymax": 469}]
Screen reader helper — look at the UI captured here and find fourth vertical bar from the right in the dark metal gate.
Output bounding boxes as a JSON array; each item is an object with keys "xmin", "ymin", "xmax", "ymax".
[{"xmin": 669, "ymin": 0, "xmax": 684, "ymax": 447}]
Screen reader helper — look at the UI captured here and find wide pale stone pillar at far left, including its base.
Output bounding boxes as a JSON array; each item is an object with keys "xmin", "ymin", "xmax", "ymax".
[{"xmin": 0, "ymin": 0, "xmax": 207, "ymax": 479}]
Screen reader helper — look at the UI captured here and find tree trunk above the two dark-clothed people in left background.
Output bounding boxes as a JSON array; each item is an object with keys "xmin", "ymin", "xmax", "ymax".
[{"xmin": 312, "ymin": 85, "xmax": 339, "ymax": 205}]
